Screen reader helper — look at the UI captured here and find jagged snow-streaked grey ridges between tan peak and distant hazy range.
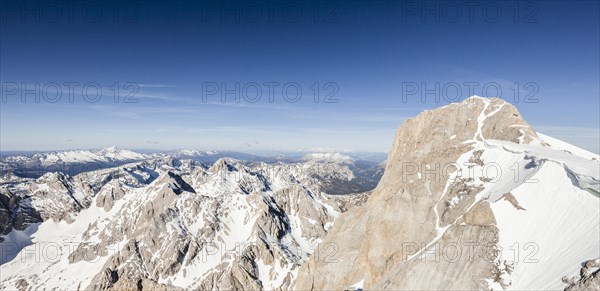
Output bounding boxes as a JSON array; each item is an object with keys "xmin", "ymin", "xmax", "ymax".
[{"xmin": 0, "ymin": 157, "xmax": 368, "ymax": 290}]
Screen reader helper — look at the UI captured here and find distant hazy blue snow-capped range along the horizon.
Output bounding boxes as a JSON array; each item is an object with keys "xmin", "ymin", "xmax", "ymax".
[{"xmin": 0, "ymin": 147, "xmax": 385, "ymax": 189}]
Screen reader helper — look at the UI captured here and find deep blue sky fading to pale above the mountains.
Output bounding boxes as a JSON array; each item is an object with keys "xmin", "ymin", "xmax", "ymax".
[{"xmin": 0, "ymin": 1, "xmax": 600, "ymax": 153}]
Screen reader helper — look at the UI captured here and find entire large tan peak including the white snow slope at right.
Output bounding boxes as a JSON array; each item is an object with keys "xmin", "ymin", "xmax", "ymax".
[{"xmin": 294, "ymin": 97, "xmax": 600, "ymax": 290}]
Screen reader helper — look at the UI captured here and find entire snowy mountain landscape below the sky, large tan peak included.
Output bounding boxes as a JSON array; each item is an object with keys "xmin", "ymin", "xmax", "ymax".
[{"xmin": 0, "ymin": 97, "xmax": 600, "ymax": 290}]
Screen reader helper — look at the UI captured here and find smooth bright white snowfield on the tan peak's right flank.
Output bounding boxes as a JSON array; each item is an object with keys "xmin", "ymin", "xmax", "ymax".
[{"xmin": 489, "ymin": 135, "xmax": 600, "ymax": 290}]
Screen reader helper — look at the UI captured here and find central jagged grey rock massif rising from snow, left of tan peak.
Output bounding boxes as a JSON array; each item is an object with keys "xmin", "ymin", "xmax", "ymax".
[{"xmin": 79, "ymin": 160, "xmax": 342, "ymax": 289}]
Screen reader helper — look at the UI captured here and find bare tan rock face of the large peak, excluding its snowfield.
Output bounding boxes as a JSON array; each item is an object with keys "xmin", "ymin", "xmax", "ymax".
[{"xmin": 294, "ymin": 97, "xmax": 597, "ymax": 290}]
